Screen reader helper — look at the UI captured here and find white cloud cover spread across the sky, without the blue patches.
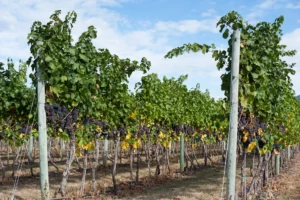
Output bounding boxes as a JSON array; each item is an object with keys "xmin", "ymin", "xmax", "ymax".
[{"xmin": 11, "ymin": 0, "xmax": 300, "ymax": 97}]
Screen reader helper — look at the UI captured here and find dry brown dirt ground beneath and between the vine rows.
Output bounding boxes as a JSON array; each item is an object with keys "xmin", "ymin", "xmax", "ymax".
[{"xmin": 0, "ymin": 153, "xmax": 300, "ymax": 200}]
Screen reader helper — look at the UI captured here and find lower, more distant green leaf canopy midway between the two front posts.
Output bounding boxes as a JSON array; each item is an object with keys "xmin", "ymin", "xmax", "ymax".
[{"xmin": 136, "ymin": 74, "xmax": 228, "ymax": 134}]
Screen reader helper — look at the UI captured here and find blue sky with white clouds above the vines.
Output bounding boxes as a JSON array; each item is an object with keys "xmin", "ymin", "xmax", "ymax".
[{"xmin": 0, "ymin": 0, "xmax": 300, "ymax": 98}]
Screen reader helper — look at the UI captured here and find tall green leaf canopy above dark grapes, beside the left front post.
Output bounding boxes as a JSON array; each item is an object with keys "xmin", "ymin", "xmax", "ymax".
[{"xmin": 28, "ymin": 11, "xmax": 151, "ymax": 129}]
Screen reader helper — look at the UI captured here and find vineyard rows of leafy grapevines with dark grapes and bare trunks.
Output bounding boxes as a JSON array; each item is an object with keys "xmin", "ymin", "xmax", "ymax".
[{"xmin": 0, "ymin": 11, "xmax": 300, "ymax": 200}]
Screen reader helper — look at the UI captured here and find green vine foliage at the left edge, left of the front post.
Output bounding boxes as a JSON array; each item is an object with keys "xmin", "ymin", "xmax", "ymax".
[{"xmin": 0, "ymin": 59, "xmax": 35, "ymax": 146}]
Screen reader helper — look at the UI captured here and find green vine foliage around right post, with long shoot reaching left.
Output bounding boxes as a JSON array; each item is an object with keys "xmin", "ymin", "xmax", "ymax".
[{"xmin": 165, "ymin": 11, "xmax": 298, "ymax": 150}]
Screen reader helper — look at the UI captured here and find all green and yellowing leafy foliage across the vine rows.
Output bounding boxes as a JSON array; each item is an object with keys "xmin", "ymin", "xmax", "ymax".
[{"xmin": 0, "ymin": 11, "xmax": 299, "ymax": 156}]
